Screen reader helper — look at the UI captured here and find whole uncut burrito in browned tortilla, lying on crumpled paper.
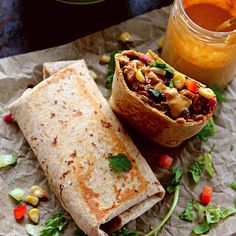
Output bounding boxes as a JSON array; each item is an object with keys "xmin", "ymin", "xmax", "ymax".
[{"xmin": 10, "ymin": 61, "xmax": 164, "ymax": 235}]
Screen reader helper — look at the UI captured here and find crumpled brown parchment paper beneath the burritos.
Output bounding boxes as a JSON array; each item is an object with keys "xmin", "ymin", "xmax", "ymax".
[{"xmin": 0, "ymin": 8, "xmax": 236, "ymax": 236}]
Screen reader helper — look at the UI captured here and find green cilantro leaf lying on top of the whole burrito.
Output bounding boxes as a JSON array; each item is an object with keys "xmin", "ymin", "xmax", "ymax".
[{"xmin": 108, "ymin": 153, "xmax": 132, "ymax": 173}]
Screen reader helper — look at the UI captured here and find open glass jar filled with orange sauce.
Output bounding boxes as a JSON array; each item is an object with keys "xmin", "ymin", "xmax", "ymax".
[{"xmin": 161, "ymin": 0, "xmax": 236, "ymax": 85}]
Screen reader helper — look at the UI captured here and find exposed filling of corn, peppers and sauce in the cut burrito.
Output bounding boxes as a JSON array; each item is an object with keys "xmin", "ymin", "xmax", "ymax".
[{"xmin": 116, "ymin": 50, "xmax": 216, "ymax": 122}]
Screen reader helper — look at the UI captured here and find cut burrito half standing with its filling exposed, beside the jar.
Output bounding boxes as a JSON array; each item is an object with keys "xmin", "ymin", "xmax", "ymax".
[{"xmin": 110, "ymin": 50, "xmax": 216, "ymax": 147}]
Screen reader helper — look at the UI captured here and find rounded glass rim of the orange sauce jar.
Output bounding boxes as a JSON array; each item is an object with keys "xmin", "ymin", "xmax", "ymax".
[{"xmin": 176, "ymin": 0, "xmax": 236, "ymax": 38}]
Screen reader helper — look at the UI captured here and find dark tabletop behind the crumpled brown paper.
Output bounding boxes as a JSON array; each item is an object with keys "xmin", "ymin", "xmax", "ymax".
[{"xmin": 0, "ymin": 0, "xmax": 172, "ymax": 57}]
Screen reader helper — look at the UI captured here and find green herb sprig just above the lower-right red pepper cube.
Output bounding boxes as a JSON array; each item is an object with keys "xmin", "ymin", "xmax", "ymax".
[{"xmin": 188, "ymin": 145, "xmax": 215, "ymax": 183}]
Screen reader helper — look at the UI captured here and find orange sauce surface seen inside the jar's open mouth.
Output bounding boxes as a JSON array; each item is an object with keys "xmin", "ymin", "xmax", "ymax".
[{"xmin": 185, "ymin": 3, "xmax": 236, "ymax": 32}]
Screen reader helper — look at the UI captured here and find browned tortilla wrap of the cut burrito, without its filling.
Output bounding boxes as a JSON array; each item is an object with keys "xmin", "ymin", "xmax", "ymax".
[{"xmin": 110, "ymin": 50, "xmax": 213, "ymax": 147}]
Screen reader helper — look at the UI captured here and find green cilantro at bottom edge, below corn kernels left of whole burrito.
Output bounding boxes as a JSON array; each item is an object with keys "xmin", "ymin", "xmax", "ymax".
[{"xmin": 40, "ymin": 213, "xmax": 67, "ymax": 236}]
